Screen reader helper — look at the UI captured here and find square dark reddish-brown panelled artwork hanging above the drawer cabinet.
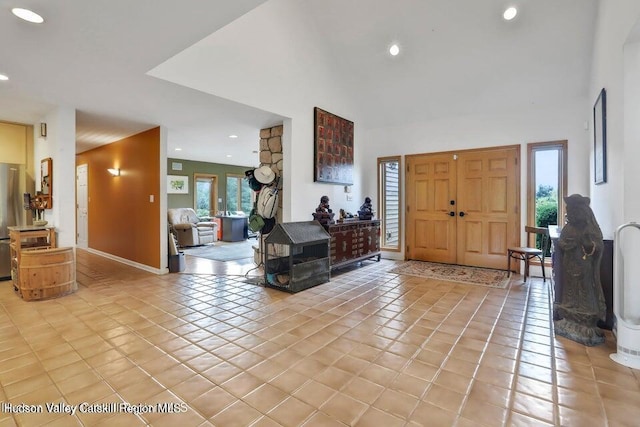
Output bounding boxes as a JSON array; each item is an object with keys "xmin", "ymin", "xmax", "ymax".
[{"xmin": 313, "ymin": 107, "xmax": 354, "ymax": 185}]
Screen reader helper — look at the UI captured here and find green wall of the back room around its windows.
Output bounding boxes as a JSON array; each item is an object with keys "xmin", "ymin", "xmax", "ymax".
[{"xmin": 167, "ymin": 159, "xmax": 254, "ymax": 210}]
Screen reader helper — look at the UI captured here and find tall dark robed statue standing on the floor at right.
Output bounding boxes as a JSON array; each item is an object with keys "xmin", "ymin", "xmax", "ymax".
[{"xmin": 554, "ymin": 194, "xmax": 606, "ymax": 346}]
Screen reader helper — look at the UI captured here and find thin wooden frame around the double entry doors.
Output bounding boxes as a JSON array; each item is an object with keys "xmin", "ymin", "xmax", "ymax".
[{"xmin": 403, "ymin": 144, "xmax": 522, "ymax": 265}]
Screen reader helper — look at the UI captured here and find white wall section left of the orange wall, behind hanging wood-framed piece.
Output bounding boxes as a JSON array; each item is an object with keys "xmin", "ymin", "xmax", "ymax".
[{"xmin": 34, "ymin": 107, "xmax": 76, "ymax": 247}]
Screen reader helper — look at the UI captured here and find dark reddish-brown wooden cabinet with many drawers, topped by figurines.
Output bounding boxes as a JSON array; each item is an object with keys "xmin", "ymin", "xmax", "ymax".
[{"xmin": 325, "ymin": 220, "xmax": 380, "ymax": 269}]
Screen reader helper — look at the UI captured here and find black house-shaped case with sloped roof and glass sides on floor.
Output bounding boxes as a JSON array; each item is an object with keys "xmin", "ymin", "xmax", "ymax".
[{"xmin": 264, "ymin": 221, "xmax": 331, "ymax": 292}]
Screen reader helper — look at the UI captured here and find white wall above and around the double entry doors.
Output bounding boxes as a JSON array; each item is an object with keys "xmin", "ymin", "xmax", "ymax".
[{"xmin": 361, "ymin": 99, "xmax": 589, "ymax": 254}]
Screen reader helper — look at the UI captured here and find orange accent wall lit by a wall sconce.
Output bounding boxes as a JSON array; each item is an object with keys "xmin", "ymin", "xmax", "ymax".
[{"xmin": 75, "ymin": 128, "xmax": 161, "ymax": 268}]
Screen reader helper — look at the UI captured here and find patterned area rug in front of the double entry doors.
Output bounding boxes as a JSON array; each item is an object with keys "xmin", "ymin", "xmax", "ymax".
[{"xmin": 389, "ymin": 261, "xmax": 509, "ymax": 288}]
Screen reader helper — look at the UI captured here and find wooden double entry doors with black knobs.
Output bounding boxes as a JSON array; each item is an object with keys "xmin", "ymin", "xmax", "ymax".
[{"xmin": 405, "ymin": 146, "xmax": 520, "ymax": 269}]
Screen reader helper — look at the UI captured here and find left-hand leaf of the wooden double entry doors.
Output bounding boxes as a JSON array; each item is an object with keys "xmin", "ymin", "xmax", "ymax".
[{"xmin": 406, "ymin": 155, "xmax": 456, "ymax": 264}]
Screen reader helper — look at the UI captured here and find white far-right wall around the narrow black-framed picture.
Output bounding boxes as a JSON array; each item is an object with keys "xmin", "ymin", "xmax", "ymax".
[{"xmin": 587, "ymin": 0, "xmax": 640, "ymax": 238}]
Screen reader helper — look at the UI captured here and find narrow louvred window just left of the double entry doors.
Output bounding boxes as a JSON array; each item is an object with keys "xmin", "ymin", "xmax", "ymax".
[{"xmin": 377, "ymin": 156, "xmax": 402, "ymax": 251}]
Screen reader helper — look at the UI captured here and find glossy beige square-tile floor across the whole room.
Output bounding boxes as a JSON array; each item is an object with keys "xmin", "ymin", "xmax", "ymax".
[{"xmin": 0, "ymin": 250, "xmax": 640, "ymax": 427}]
